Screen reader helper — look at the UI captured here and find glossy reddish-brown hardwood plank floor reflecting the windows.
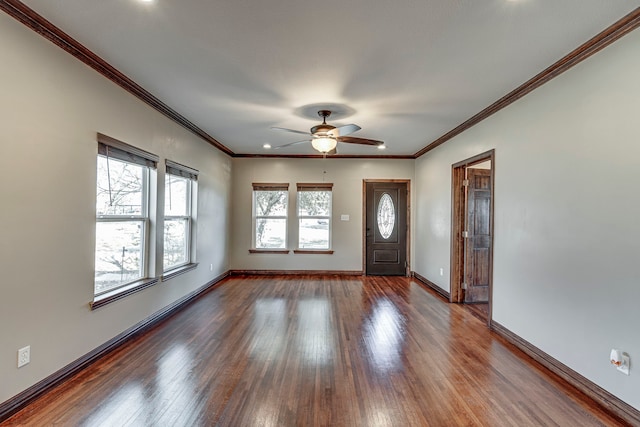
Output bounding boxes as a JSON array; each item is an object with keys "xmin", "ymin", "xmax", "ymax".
[{"xmin": 2, "ymin": 276, "xmax": 622, "ymax": 426}]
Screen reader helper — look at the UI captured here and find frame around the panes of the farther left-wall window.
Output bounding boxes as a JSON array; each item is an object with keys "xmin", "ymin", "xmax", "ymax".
[{"xmin": 162, "ymin": 159, "xmax": 199, "ymax": 281}]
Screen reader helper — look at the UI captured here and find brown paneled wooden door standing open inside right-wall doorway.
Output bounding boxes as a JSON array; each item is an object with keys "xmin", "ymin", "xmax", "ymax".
[{"xmin": 463, "ymin": 168, "xmax": 491, "ymax": 303}]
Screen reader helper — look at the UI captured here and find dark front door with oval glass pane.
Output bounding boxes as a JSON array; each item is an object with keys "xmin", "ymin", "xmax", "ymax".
[{"xmin": 365, "ymin": 182, "xmax": 408, "ymax": 276}]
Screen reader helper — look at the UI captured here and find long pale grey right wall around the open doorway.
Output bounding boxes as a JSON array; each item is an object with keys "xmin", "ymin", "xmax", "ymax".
[{"xmin": 414, "ymin": 26, "xmax": 640, "ymax": 409}]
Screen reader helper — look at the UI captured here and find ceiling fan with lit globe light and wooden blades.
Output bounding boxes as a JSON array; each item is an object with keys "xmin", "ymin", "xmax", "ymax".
[{"xmin": 271, "ymin": 110, "xmax": 384, "ymax": 154}]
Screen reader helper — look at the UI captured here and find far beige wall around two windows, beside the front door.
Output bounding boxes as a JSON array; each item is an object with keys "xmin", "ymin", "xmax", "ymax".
[{"xmin": 231, "ymin": 158, "xmax": 414, "ymax": 271}]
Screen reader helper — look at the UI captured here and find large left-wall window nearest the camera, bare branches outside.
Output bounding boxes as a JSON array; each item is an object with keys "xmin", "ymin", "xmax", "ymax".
[{"xmin": 94, "ymin": 134, "xmax": 158, "ymax": 296}]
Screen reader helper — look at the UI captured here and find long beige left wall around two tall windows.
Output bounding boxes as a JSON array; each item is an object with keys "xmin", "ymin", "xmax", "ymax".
[{"xmin": 0, "ymin": 13, "xmax": 231, "ymax": 402}]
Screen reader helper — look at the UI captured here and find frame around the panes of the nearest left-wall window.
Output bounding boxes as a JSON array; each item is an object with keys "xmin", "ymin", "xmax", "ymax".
[{"xmin": 90, "ymin": 133, "xmax": 159, "ymax": 309}]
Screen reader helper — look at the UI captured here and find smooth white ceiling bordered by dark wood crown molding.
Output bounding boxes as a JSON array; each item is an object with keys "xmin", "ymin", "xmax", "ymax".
[{"xmin": 17, "ymin": 0, "xmax": 640, "ymax": 155}]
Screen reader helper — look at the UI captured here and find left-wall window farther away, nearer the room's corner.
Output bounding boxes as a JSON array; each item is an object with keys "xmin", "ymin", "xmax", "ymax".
[{"xmin": 163, "ymin": 160, "xmax": 198, "ymax": 272}]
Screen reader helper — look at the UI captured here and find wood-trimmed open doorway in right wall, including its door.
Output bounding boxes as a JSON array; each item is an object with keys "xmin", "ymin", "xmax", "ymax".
[{"xmin": 451, "ymin": 150, "xmax": 495, "ymax": 325}]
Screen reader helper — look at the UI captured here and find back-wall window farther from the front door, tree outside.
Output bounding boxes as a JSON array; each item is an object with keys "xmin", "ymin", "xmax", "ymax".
[{"xmin": 253, "ymin": 184, "xmax": 289, "ymax": 250}]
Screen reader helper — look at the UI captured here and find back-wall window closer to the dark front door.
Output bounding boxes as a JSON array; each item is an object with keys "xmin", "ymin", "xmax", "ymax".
[{"xmin": 298, "ymin": 183, "xmax": 333, "ymax": 250}]
